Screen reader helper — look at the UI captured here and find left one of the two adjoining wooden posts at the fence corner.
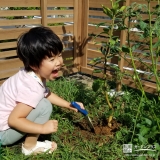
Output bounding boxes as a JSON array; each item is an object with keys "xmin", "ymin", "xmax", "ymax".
[{"xmin": 73, "ymin": 0, "xmax": 82, "ymax": 71}]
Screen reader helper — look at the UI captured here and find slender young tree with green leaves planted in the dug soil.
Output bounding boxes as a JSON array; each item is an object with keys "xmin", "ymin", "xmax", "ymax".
[{"xmin": 90, "ymin": 0, "xmax": 126, "ymax": 127}]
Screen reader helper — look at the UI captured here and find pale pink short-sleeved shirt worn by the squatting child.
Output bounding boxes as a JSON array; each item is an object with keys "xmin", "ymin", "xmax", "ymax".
[{"xmin": 0, "ymin": 68, "xmax": 49, "ymax": 131}]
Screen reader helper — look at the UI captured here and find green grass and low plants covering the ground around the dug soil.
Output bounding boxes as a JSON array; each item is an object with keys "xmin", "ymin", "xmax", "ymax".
[{"xmin": 0, "ymin": 78, "xmax": 160, "ymax": 160}]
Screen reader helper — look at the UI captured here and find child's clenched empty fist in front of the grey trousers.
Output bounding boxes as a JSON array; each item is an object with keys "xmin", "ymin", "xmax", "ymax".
[{"xmin": 42, "ymin": 120, "xmax": 58, "ymax": 134}]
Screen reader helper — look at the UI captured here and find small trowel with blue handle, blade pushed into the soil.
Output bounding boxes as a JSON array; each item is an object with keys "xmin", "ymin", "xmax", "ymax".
[{"xmin": 71, "ymin": 102, "xmax": 95, "ymax": 133}]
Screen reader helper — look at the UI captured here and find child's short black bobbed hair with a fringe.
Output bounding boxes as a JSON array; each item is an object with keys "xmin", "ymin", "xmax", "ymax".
[{"xmin": 17, "ymin": 27, "xmax": 63, "ymax": 71}]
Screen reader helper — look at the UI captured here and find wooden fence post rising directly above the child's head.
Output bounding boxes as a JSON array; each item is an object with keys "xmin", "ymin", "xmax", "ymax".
[{"xmin": 40, "ymin": 0, "xmax": 47, "ymax": 26}]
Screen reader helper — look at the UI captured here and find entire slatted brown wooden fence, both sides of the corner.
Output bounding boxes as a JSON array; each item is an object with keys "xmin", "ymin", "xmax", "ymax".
[{"xmin": 0, "ymin": 0, "xmax": 159, "ymax": 93}]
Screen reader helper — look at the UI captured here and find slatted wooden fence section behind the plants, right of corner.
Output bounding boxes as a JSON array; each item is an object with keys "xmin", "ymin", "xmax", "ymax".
[{"xmin": 81, "ymin": 0, "xmax": 160, "ymax": 94}]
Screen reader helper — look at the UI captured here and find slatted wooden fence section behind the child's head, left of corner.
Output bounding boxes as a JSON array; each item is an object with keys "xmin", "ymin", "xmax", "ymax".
[{"xmin": 0, "ymin": 0, "xmax": 81, "ymax": 84}]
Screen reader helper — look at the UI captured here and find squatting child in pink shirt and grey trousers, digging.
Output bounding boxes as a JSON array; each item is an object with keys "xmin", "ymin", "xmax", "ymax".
[{"xmin": 0, "ymin": 27, "xmax": 84, "ymax": 155}]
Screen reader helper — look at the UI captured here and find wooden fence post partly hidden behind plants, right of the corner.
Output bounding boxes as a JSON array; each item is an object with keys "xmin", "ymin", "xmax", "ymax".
[{"xmin": 116, "ymin": 0, "xmax": 130, "ymax": 91}]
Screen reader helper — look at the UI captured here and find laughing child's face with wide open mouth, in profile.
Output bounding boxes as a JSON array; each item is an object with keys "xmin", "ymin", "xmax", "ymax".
[{"xmin": 35, "ymin": 53, "xmax": 63, "ymax": 81}]
